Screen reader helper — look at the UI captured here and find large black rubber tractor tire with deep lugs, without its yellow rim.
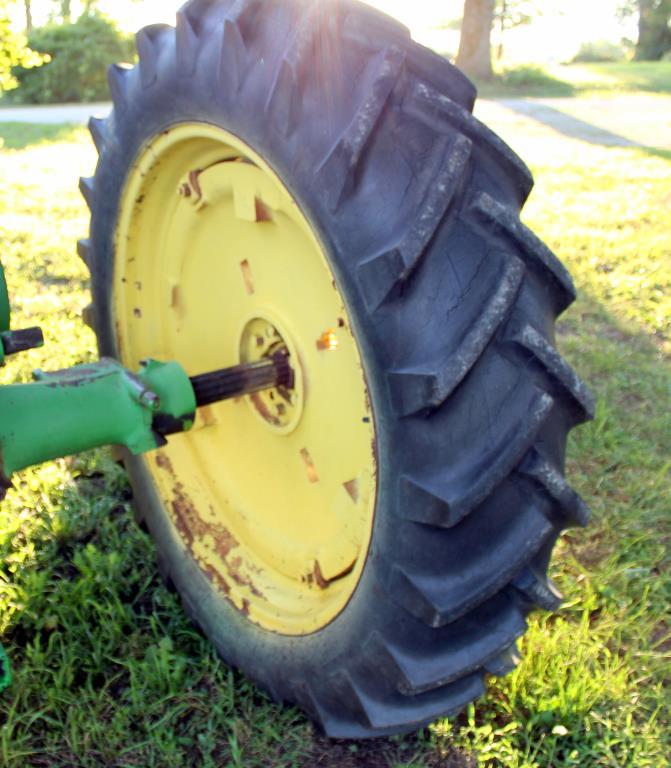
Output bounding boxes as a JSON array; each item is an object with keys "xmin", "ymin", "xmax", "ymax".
[{"xmin": 80, "ymin": 0, "xmax": 593, "ymax": 738}]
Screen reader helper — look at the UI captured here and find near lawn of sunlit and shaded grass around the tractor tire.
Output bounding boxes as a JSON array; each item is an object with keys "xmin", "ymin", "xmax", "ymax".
[{"xmin": 0, "ymin": 115, "xmax": 671, "ymax": 768}]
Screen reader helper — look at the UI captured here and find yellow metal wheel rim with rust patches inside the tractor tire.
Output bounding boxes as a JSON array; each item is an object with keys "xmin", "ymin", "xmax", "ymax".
[{"xmin": 113, "ymin": 123, "xmax": 377, "ymax": 635}]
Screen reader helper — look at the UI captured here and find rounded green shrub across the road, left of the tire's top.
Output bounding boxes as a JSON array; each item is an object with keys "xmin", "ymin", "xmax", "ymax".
[{"xmin": 14, "ymin": 14, "xmax": 133, "ymax": 104}]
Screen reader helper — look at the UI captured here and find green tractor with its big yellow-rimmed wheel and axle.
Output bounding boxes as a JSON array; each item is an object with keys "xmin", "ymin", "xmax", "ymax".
[{"xmin": 0, "ymin": 0, "xmax": 593, "ymax": 738}]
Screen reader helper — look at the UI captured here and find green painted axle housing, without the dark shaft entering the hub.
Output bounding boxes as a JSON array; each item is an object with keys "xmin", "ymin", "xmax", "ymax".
[{"xmin": 0, "ymin": 359, "xmax": 196, "ymax": 488}]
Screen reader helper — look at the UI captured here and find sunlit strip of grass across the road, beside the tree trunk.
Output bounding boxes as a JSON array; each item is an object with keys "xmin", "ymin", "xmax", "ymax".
[{"xmin": 477, "ymin": 61, "xmax": 671, "ymax": 98}]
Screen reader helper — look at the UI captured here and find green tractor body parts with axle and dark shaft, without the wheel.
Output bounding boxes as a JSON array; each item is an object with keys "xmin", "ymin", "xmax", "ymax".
[{"xmin": 0, "ymin": 264, "xmax": 294, "ymax": 691}]
